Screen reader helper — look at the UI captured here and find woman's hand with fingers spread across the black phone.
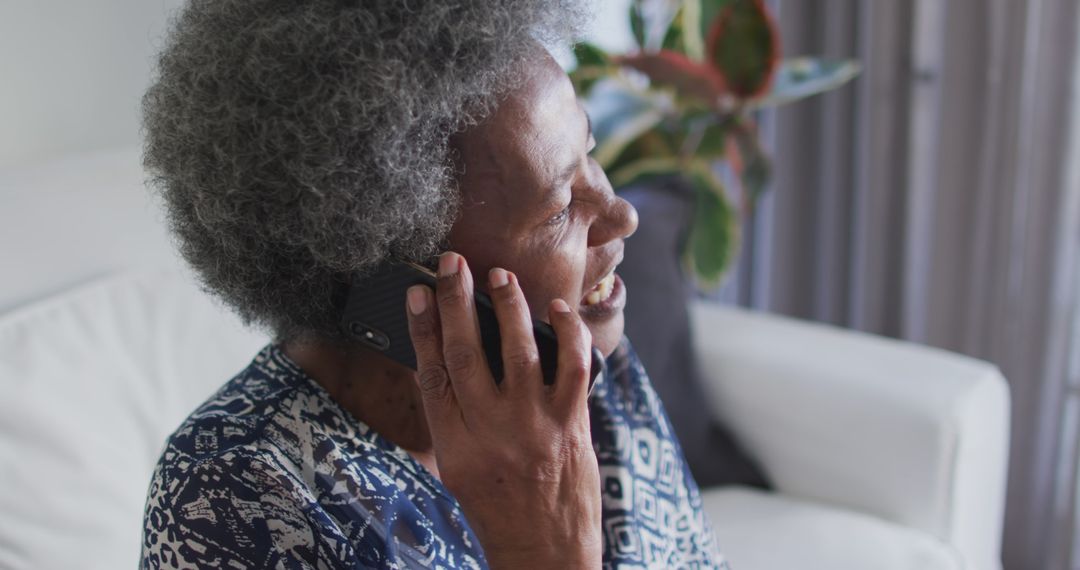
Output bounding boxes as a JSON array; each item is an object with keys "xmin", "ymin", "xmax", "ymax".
[{"xmin": 408, "ymin": 253, "xmax": 603, "ymax": 569}]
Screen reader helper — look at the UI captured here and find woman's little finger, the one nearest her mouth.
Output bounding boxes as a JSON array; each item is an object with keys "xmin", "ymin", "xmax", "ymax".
[{"xmin": 548, "ymin": 299, "xmax": 593, "ymax": 413}]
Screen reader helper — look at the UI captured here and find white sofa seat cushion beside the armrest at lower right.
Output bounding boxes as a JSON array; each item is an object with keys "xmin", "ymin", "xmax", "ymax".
[{"xmin": 702, "ymin": 487, "xmax": 960, "ymax": 570}]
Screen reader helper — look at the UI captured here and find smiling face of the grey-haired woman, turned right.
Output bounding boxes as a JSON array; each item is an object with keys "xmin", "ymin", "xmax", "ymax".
[{"xmin": 449, "ymin": 53, "xmax": 637, "ymax": 355}]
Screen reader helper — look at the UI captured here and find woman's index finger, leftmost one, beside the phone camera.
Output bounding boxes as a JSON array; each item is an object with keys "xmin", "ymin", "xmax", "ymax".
[{"xmin": 405, "ymin": 285, "xmax": 461, "ymax": 433}]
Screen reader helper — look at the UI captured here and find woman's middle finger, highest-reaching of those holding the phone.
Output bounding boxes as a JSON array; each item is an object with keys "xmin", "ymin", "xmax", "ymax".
[{"xmin": 435, "ymin": 252, "xmax": 497, "ymax": 403}]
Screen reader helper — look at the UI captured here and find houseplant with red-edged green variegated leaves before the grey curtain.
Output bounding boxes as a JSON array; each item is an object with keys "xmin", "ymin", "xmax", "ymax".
[{"xmin": 570, "ymin": 0, "xmax": 859, "ymax": 287}]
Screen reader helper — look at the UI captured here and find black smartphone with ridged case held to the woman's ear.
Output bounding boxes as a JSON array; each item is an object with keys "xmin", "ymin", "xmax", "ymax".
[{"xmin": 341, "ymin": 260, "xmax": 604, "ymax": 393}]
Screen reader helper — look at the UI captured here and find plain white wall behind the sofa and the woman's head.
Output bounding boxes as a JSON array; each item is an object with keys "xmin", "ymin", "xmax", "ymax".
[{"xmin": 0, "ymin": 0, "xmax": 632, "ymax": 169}]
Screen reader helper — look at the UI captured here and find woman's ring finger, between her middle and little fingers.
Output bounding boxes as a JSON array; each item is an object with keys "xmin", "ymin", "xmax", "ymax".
[{"xmin": 488, "ymin": 268, "xmax": 543, "ymax": 394}]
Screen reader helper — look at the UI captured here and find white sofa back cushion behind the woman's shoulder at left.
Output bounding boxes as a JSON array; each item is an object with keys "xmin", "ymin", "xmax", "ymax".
[{"xmin": 0, "ymin": 270, "xmax": 267, "ymax": 569}]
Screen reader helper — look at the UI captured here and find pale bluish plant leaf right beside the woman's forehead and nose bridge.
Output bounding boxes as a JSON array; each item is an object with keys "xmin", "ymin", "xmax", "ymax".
[{"xmin": 585, "ymin": 78, "xmax": 664, "ymax": 168}]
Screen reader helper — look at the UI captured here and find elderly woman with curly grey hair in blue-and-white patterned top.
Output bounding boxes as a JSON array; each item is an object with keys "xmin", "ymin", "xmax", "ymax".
[{"xmin": 143, "ymin": 0, "xmax": 726, "ymax": 569}]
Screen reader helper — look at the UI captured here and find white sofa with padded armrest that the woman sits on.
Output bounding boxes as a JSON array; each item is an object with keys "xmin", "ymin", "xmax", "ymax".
[{"xmin": 0, "ymin": 149, "xmax": 1009, "ymax": 570}]
